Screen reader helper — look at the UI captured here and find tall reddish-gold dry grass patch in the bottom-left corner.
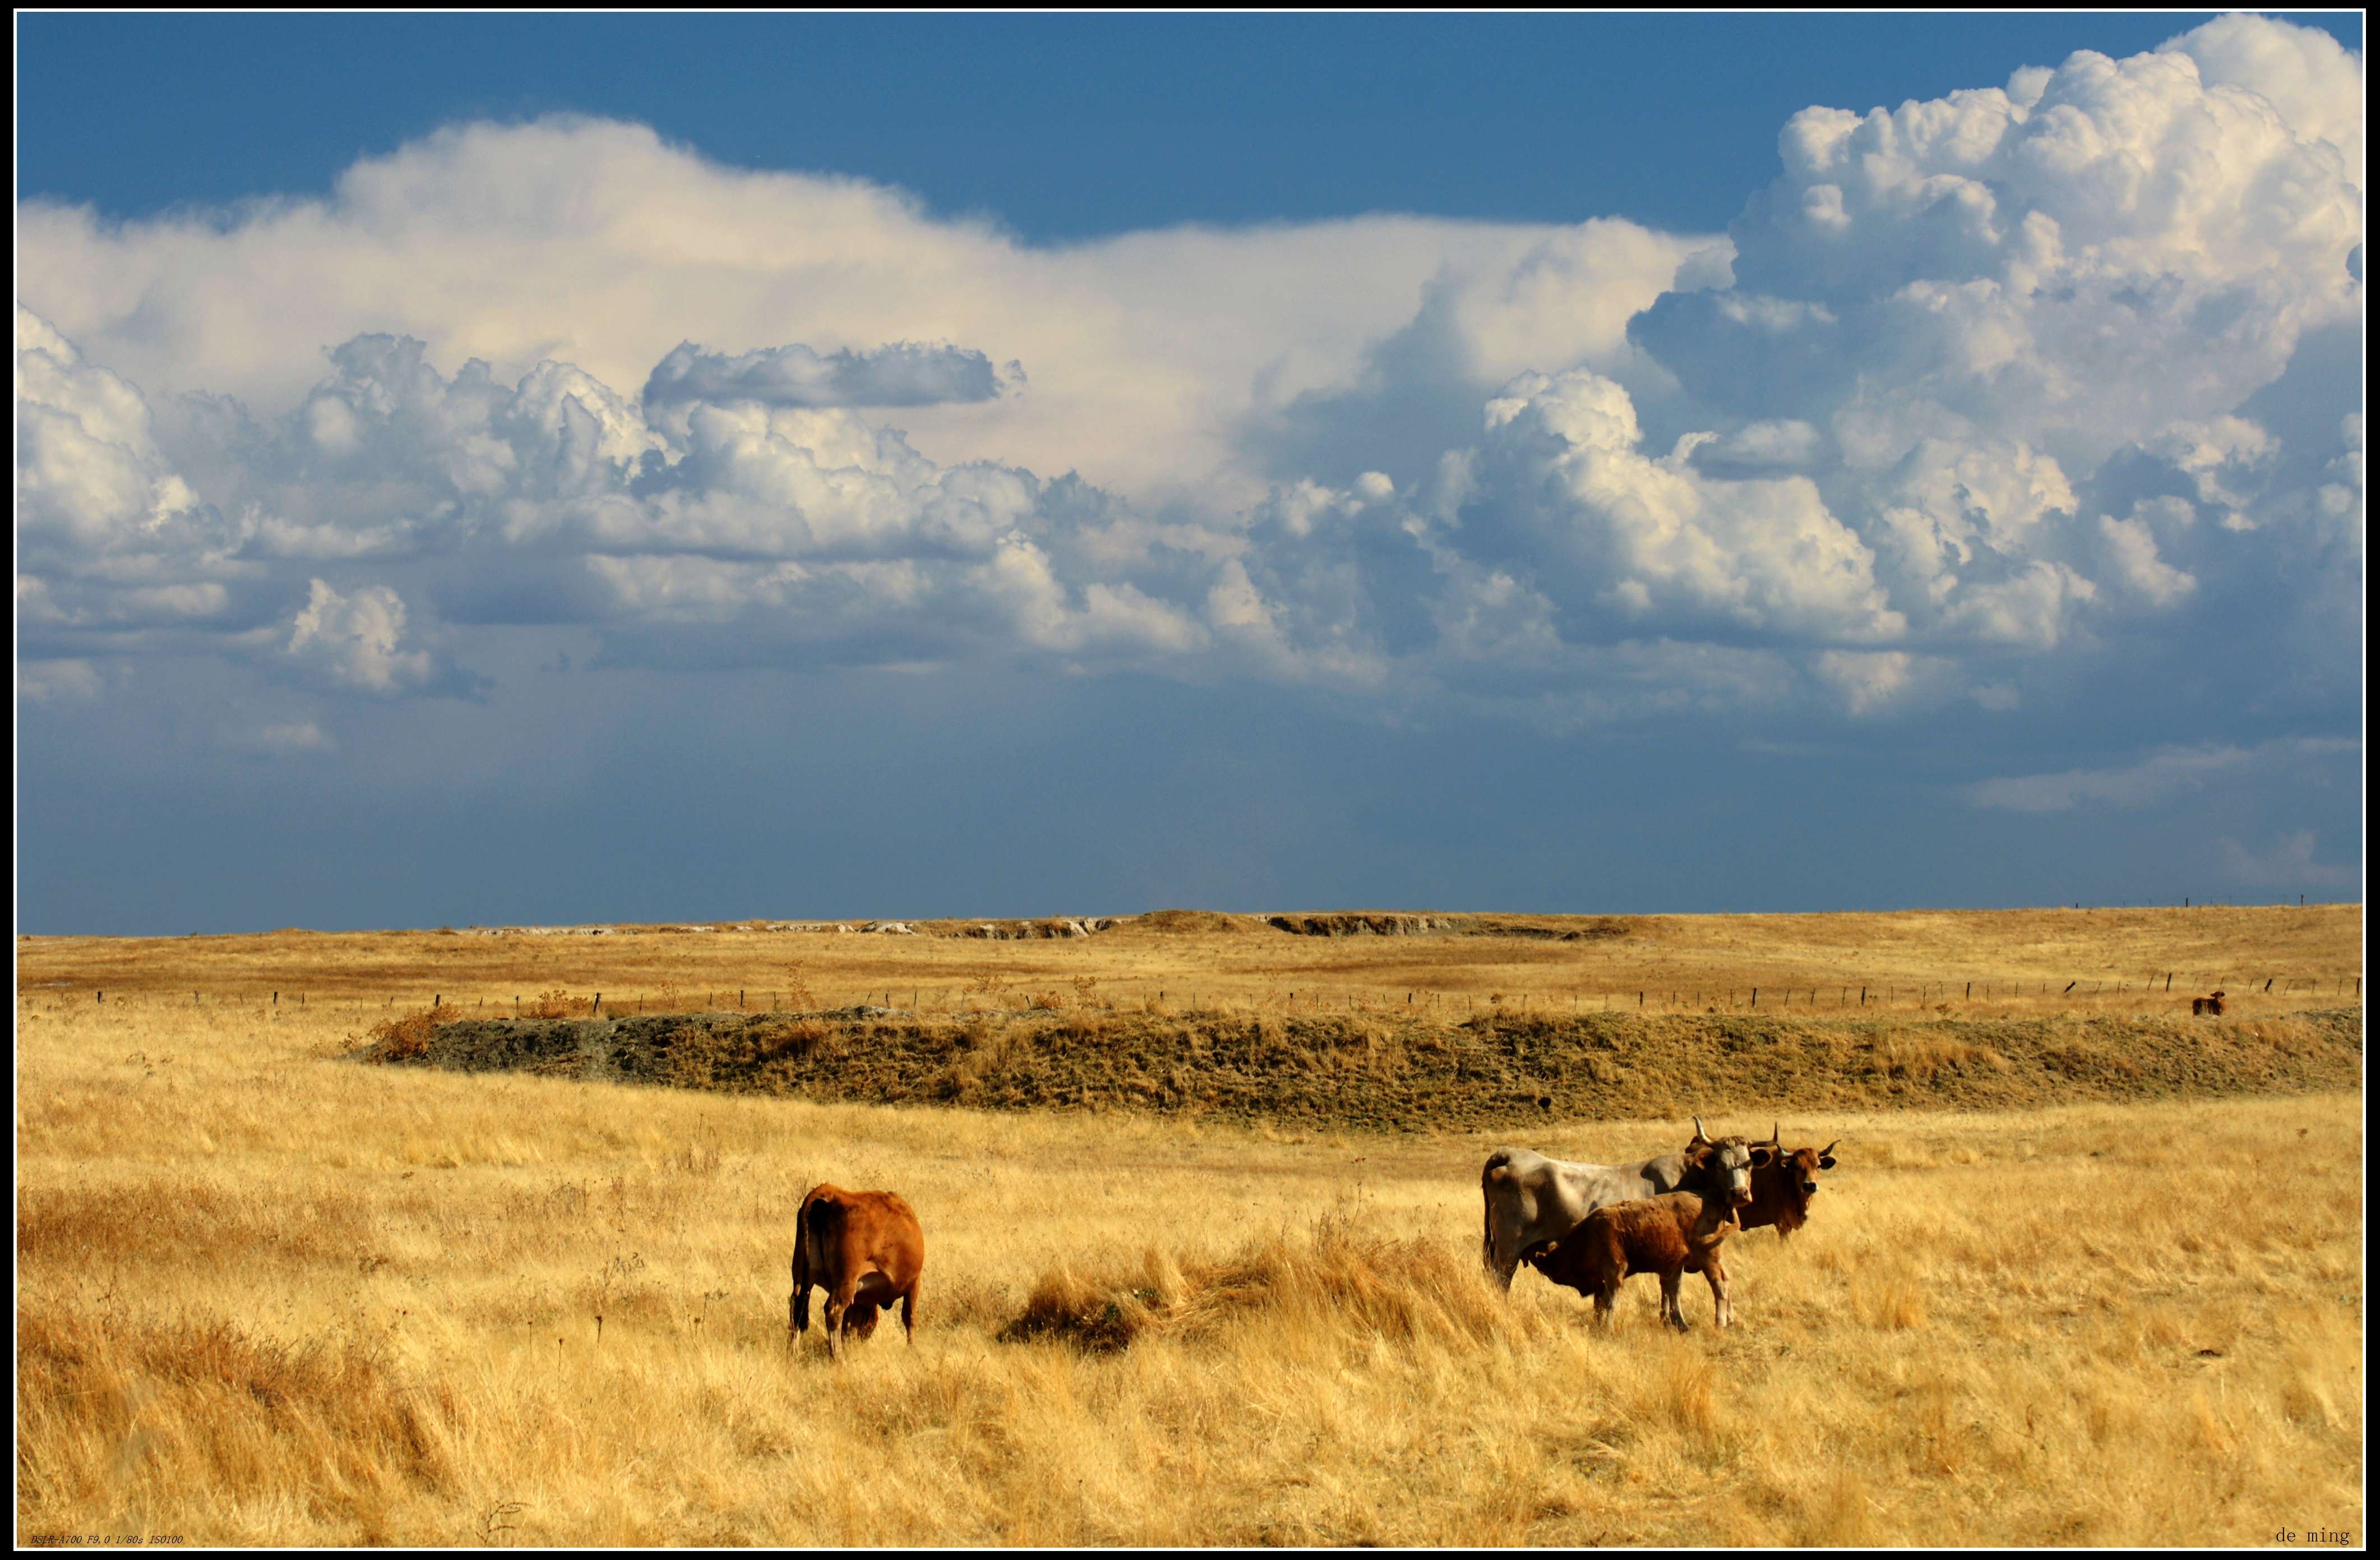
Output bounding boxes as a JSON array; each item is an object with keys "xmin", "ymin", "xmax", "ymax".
[{"xmin": 17, "ymin": 1308, "xmax": 457, "ymax": 1527}]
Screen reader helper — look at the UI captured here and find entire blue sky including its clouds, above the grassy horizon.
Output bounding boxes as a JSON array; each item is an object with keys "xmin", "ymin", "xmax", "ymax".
[{"xmin": 17, "ymin": 14, "xmax": 2363, "ymax": 934}]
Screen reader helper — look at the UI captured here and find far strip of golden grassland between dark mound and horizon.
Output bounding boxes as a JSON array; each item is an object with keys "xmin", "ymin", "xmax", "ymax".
[{"xmin": 17, "ymin": 905, "xmax": 2363, "ymax": 1017}]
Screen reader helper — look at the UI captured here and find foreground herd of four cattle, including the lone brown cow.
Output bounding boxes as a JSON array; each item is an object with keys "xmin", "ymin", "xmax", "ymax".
[{"xmin": 785, "ymin": 1117, "xmax": 1840, "ymax": 1358}]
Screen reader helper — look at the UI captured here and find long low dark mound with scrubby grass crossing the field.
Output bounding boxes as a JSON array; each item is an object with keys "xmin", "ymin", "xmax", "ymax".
[{"xmin": 357, "ymin": 1008, "xmax": 2363, "ymax": 1131}]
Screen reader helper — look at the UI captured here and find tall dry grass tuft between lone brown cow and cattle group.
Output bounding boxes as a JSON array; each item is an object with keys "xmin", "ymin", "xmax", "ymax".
[{"xmin": 1000, "ymin": 1220, "xmax": 1535, "ymax": 1350}]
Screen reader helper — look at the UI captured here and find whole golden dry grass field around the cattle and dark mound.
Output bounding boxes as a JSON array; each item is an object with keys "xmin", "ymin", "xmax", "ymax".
[{"xmin": 17, "ymin": 907, "xmax": 2363, "ymax": 1546}]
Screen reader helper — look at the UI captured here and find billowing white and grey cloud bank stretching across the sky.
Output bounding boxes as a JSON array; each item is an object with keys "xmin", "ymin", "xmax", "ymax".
[{"xmin": 17, "ymin": 17, "xmax": 2363, "ymax": 748}]
